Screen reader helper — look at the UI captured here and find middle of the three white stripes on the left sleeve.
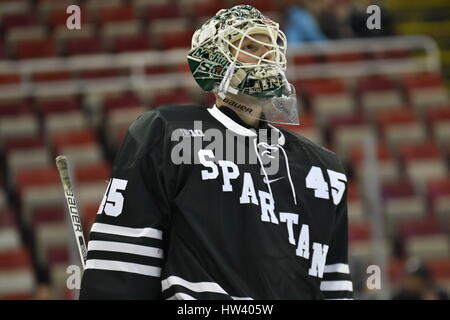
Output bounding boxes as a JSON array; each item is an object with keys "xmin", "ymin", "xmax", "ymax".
[{"xmin": 88, "ymin": 240, "xmax": 163, "ymax": 259}]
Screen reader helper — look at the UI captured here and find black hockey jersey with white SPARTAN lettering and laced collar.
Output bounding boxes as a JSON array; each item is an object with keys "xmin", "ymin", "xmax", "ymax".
[{"xmin": 80, "ymin": 106, "xmax": 353, "ymax": 299}]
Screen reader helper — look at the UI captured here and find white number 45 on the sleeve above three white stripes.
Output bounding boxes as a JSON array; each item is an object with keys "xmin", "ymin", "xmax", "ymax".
[{"xmin": 97, "ymin": 178, "xmax": 128, "ymax": 217}]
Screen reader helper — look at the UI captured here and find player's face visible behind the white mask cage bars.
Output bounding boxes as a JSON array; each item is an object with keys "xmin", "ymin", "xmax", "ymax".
[{"xmin": 230, "ymin": 34, "xmax": 273, "ymax": 63}]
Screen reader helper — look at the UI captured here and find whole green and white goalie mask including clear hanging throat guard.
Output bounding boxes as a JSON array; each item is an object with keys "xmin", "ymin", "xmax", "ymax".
[{"xmin": 187, "ymin": 5, "xmax": 298, "ymax": 124}]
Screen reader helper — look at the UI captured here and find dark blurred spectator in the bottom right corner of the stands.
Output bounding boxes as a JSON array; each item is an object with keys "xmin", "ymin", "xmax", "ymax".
[{"xmin": 392, "ymin": 258, "xmax": 449, "ymax": 300}]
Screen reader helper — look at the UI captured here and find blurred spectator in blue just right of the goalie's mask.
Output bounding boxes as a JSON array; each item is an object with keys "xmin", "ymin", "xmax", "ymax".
[{"xmin": 284, "ymin": 0, "xmax": 327, "ymax": 44}]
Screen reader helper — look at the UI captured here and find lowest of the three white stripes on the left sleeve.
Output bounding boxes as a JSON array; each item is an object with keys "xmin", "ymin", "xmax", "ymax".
[{"xmin": 86, "ymin": 259, "xmax": 161, "ymax": 277}]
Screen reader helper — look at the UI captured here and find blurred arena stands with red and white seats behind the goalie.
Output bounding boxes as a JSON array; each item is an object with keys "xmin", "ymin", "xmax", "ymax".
[{"xmin": 0, "ymin": 0, "xmax": 450, "ymax": 299}]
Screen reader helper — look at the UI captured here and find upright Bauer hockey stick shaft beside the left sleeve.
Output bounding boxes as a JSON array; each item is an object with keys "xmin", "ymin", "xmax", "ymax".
[{"xmin": 56, "ymin": 156, "xmax": 87, "ymax": 270}]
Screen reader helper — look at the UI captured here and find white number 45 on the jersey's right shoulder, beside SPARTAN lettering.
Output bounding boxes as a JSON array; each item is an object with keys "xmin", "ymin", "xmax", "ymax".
[{"xmin": 306, "ymin": 166, "xmax": 347, "ymax": 205}]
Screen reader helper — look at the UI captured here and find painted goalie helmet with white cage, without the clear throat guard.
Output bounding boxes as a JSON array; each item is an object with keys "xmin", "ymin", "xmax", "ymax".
[{"xmin": 188, "ymin": 5, "xmax": 290, "ymax": 97}]
